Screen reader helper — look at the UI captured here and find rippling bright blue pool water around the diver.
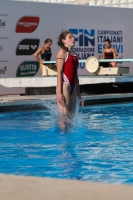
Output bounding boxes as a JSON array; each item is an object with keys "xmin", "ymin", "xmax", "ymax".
[{"xmin": 0, "ymin": 104, "xmax": 133, "ymax": 184}]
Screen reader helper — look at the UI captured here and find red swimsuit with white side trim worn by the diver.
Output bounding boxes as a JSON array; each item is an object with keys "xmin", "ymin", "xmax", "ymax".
[{"xmin": 63, "ymin": 53, "xmax": 78, "ymax": 94}]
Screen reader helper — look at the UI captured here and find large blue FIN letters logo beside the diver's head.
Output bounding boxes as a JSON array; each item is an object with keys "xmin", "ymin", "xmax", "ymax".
[{"xmin": 69, "ymin": 28, "xmax": 95, "ymax": 47}]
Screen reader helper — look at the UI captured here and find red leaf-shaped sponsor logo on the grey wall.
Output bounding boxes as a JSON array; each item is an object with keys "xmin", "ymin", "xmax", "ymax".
[{"xmin": 16, "ymin": 16, "xmax": 40, "ymax": 33}]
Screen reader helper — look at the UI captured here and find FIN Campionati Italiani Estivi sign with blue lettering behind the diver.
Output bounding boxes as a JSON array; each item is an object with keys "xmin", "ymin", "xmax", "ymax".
[{"xmin": 66, "ymin": 23, "xmax": 124, "ymax": 73}]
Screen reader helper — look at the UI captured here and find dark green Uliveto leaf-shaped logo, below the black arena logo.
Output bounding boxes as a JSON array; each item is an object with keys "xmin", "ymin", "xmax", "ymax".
[{"xmin": 16, "ymin": 61, "xmax": 39, "ymax": 77}]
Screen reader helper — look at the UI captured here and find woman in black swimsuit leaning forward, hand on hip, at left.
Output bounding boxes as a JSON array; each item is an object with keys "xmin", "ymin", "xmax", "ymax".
[{"xmin": 34, "ymin": 38, "xmax": 52, "ymax": 73}]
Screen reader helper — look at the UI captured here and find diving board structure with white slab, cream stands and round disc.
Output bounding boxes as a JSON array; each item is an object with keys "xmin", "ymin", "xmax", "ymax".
[{"xmin": 0, "ymin": 57, "xmax": 133, "ymax": 88}]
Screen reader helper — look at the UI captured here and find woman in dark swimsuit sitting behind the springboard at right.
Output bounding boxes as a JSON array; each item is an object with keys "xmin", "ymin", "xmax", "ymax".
[{"xmin": 100, "ymin": 39, "xmax": 116, "ymax": 67}]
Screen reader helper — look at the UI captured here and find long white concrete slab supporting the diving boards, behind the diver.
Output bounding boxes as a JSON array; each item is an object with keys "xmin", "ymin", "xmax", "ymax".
[{"xmin": 0, "ymin": 74, "xmax": 133, "ymax": 88}]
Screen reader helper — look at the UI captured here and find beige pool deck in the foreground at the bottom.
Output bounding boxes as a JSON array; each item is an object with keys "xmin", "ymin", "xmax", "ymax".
[{"xmin": 0, "ymin": 174, "xmax": 133, "ymax": 200}]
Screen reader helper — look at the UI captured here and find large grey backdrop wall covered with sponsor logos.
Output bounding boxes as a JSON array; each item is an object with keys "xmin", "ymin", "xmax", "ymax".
[{"xmin": 0, "ymin": 0, "xmax": 133, "ymax": 95}]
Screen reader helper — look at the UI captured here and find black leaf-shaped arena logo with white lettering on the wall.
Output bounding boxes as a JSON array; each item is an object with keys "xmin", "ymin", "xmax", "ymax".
[{"xmin": 16, "ymin": 39, "xmax": 40, "ymax": 55}]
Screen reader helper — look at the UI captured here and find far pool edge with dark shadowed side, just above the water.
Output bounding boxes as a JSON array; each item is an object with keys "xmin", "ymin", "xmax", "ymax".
[{"xmin": 0, "ymin": 93, "xmax": 133, "ymax": 112}]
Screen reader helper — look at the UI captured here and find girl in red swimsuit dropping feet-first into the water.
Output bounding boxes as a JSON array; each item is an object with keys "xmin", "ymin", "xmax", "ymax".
[{"xmin": 56, "ymin": 31, "xmax": 84, "ymax": 128}]
